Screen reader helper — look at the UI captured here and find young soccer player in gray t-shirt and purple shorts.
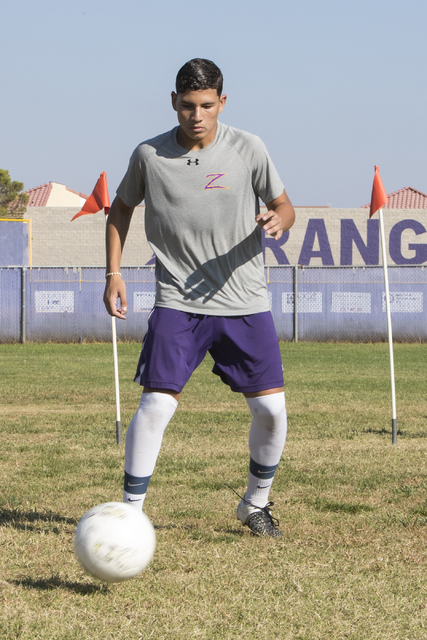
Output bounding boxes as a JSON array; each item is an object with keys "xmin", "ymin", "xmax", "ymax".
[{"xmin": 104, "ymin": 58, "xmax": 295, "ymax": 537}]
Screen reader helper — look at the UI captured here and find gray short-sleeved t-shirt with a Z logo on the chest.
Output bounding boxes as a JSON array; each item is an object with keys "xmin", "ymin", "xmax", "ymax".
[{"xmin": 117, "ymin": 122, "xmax": 283, "ymax": 316}]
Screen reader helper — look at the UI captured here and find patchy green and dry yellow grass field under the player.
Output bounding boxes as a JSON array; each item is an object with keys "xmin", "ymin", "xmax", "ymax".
[{"xmin": 0, "ymin": 343, "xmax": 427, "ymax": 640}]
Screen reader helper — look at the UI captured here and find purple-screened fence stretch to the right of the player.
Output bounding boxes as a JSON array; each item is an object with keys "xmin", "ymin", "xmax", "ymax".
[{"xmin": 266, "ymin": 266, "xmax": 427, "ymax": 342}]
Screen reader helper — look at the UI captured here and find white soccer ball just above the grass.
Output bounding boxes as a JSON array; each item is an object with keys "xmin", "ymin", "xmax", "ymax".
[{"xmin": 74, "ymin": 502, "xmax": 156, "ymax": 582}]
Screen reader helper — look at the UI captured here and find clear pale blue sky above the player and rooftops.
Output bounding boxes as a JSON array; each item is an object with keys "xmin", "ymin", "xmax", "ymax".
[{"xmin": 0, "ymin": 0, "xmax": 427, "ymax": 207}]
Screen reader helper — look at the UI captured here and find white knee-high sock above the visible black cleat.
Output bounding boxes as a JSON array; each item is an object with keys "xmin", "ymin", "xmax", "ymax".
[{"xmin": 245, "ymin": 392, "xmax": 287, "ymax": 507}]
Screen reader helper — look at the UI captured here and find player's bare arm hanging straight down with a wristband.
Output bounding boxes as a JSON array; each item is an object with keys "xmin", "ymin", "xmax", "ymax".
[{"xmin": 104, "ymin": 196, "xmax": 134, "ymax": 320}]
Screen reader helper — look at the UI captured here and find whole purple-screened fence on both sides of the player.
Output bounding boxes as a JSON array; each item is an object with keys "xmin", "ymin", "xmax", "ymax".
[{"xmin": 0, "ymin": 266, "xmax": 427, "ymax": 342}]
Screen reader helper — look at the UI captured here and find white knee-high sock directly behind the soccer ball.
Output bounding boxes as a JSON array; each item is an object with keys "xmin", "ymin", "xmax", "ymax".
[{"xmin": 123, "ymin": 391, "xmax": 178, "ymax": 508}]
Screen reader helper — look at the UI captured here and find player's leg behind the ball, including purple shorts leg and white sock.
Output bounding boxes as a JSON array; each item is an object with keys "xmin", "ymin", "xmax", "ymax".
[{"xmin": 123, "ymin": 307, "xmax": 211, "ymax": 508}]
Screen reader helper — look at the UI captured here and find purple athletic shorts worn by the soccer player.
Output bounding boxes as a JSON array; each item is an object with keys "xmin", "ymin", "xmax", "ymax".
[{"xmin": 135, "ymin": 307, "xmax": 283, "ymax": 393}]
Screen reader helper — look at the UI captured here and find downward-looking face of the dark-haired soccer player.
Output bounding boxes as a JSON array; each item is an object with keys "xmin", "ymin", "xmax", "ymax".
[{"xmin": 172, "ymin": 89, "xmax": 227, "ymax": 151}]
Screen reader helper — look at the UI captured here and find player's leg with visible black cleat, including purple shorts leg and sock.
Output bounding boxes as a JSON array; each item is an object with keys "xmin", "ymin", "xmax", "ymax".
[{"xmin": 209, "ymin": 311, "xmax": 287, "ymax": 537}]
